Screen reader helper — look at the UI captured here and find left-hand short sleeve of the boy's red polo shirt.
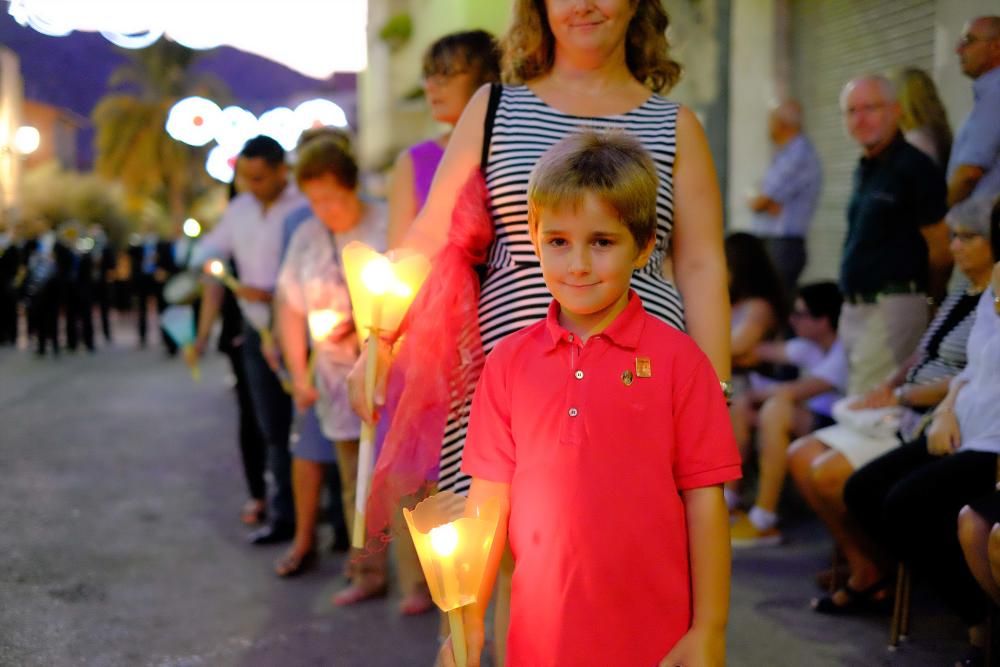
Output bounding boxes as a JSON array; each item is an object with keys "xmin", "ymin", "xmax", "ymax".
[{"xmin": 462, "ymin": 342, "xmax": 516, "ymax": 484}]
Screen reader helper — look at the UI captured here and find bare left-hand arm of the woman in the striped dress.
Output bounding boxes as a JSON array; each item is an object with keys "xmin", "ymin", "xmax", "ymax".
[{"xmin": 399, "ymin": 85, "xmax": 490, "ymax": 257}]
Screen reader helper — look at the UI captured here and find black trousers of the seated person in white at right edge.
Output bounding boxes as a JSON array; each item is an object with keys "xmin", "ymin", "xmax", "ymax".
[{"xmin": 844, "ymin": 437, "xmax": 997, "ymax": 626}]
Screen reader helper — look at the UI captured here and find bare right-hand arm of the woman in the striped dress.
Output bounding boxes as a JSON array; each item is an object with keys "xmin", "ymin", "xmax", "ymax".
[{"xmin": 673, "ymin": 107, "xmax": 731, "ymax": 380}]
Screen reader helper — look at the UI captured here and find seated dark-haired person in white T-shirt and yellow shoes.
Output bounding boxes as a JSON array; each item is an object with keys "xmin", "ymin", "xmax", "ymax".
[{"xmin": 727, "ymin": 283, "xmax": 847, "ymax": 547}]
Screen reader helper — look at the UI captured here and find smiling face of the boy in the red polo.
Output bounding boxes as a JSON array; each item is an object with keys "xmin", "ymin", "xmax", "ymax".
[{"xmin": 532, "ymin": 194, "xmax": 655, "ymax": 333}]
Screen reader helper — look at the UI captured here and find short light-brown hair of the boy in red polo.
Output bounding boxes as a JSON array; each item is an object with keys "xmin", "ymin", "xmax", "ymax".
[{"xmin": 528, "ymin": 130, "xmax": 658, "ymax": 249}]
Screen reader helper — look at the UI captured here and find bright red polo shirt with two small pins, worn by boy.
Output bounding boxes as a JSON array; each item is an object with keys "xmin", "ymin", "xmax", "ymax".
[{"xmin": 462, "ymin": 293, "xmax": 740, "ymax": 667}]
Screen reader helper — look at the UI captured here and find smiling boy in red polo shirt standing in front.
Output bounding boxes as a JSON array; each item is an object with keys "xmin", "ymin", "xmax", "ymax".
[{"xmin": 442, "ymin": 132, "xmax": 740, "ymax": 667}]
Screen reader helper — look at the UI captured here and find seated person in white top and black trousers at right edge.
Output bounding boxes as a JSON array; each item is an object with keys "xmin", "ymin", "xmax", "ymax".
[{"xmin": 844, "ymin": 194, "xmax": 1000, "ymax": 664}]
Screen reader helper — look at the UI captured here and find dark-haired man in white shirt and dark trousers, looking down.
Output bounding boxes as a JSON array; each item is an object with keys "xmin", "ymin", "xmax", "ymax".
[{"xmin": 192, "ymin": 135, "xmax": 307, "ymax": 544}]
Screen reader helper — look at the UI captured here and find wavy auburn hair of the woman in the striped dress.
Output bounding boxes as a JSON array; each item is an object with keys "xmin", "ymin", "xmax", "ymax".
[{"xmin": 500, "ymin": 0, "xmax": 681, "ymax": 92}]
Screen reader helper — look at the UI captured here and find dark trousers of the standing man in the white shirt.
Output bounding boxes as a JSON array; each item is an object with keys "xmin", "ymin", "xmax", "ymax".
[{"xmin": 241, "ymin": 325, "xmax": 295, "ymax": 524}]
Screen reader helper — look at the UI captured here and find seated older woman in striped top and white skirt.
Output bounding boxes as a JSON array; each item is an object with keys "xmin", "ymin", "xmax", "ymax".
[{"xmin": 788, "ymin": 194, "xmax": 994, "ymax": 613}]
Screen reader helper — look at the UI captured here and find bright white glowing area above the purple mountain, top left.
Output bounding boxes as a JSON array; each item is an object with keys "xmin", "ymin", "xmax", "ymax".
[{"xmin": 8, "ymin": 0, "xmax": 368, "ymax": 79}]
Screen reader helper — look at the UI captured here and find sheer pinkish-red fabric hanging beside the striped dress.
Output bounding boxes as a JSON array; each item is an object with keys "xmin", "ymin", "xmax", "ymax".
[{"xmin": 366, "ymin": 169, "xmax": 494, "ymax": 538}]
